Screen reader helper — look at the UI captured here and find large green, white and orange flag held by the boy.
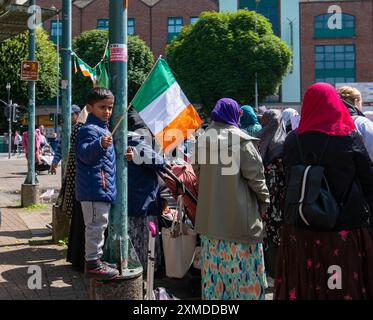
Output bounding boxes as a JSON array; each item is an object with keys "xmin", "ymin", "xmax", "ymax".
[{"xmin": 131, "ymin": 59, "xmax": 202, "ymax": 151}]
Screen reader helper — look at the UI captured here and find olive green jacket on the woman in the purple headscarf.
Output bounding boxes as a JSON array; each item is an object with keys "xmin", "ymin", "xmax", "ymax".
[{"xmin": 193, "ymin": 122, "xmax": 269, "ymax": 244}]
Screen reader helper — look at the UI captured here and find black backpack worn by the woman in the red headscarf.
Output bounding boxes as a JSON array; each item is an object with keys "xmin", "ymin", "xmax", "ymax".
[{"xmin": 284, "ymin": 134, "xmax": 342, "ymax": 230}]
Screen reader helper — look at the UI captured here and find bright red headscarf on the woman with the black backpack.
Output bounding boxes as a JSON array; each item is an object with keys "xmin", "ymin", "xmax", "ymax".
[{"xmin": 297, "ymin": 82, "xmax": 356, "ymax": 136}]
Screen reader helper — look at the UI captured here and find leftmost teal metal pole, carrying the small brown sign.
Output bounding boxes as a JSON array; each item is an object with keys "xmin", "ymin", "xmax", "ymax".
[{"xmin": 25, "ymin": 0, "xmax": 36, "ymax": 185}]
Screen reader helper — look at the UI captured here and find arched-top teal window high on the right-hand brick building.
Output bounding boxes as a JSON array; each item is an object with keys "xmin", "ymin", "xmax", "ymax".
[{"xmin": 314, "ymin": 13, "xmax": 355, "ymax": 38}]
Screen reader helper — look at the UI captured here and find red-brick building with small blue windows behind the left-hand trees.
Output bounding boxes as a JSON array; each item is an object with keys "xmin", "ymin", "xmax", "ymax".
[{"xmin": 37, "ymin": 0, "xmax": 218, "ymax": 57}]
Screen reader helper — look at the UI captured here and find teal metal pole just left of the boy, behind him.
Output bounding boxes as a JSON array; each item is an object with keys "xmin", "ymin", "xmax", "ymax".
[{"xmin": 61, "ymin": 0, "xmax": 72, "ymax": 177}]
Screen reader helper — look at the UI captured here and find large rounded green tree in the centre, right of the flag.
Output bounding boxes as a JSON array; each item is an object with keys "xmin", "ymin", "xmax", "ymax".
[{"xmin": 167, "ymin": 10, "xmax": 291, "ymax": 113}]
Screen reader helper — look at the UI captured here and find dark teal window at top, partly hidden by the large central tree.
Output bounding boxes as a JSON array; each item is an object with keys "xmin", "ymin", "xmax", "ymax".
[{"xmin": 239, "ymin": 0, "xmax": 280, "ymax": 36}]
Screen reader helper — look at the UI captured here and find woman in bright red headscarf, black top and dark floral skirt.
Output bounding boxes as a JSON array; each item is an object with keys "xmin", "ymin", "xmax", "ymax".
[{"xmin": 275, "ymin": 83, "xmax": 373, "ymax": 300}]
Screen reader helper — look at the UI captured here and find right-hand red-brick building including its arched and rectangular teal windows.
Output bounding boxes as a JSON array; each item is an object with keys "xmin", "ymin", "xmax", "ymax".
[{"xmin": 300, "ymin": 0, "xmax": 373, "ymax": 96}]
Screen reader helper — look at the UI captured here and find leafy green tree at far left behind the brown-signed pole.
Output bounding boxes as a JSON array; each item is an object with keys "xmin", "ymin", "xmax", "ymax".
[{"xmin": 0, "ymin": 28, "xmax": 57, "ymax": 134}]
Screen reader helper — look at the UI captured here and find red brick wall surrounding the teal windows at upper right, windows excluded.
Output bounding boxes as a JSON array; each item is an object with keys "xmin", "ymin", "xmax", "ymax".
[{"xmin": 300, "ymin": 0, "xmax": 373, "ymax": 97}]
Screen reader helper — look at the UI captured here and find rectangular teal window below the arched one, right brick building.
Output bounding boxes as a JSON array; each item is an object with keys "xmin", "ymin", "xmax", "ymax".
[{"xmin": 315, "ymin": 44, "xmax": 355, "ymax": 85}]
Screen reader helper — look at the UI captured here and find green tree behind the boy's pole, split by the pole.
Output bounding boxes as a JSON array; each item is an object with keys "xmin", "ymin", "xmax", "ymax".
[{"xmin": 73, "ymin": 30, "xmax": 154, "ymax": 106}]
